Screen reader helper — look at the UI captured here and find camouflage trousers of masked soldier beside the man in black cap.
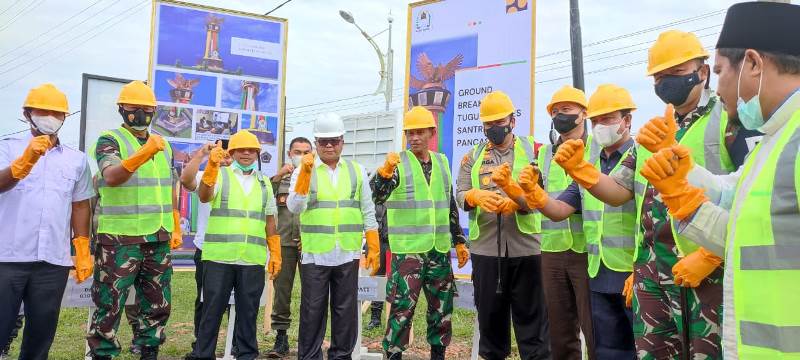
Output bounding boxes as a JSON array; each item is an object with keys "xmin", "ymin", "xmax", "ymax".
[{"xmin": 633, "ymin": 263, "xmax": 722, "ymax": 360}]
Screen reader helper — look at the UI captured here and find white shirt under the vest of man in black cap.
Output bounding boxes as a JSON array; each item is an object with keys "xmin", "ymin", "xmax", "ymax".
[{"xmin": 679, "ymin": 92, "xmax": 800, "ymax": 359}]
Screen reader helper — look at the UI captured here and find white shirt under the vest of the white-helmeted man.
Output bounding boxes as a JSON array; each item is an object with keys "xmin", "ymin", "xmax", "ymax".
[{"xmin": 286, "ymin": 158, "xmax": 378, "ymax": 266}]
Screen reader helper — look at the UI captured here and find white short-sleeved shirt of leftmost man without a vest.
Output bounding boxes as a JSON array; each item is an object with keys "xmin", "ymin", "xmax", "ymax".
[{"xmin": 0, "ymin": 134, "xmax": 95, "ymax": 266}]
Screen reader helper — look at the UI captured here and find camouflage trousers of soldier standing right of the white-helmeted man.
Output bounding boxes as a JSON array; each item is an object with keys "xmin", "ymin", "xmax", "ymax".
[{"xmin": 383, "ymin": 249, "xmax": 456, "ymax": 353}]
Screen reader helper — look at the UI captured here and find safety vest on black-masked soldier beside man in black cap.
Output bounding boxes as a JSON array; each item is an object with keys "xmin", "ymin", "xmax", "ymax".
[{"xmin": 633, "ymin": 101, "xmax": 734, "ymax": 259}]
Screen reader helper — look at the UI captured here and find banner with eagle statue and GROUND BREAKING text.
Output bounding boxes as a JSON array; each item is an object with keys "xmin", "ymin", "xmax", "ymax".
[{"xmin": 406, "ymin": 0, "xmax": 536, "ymax": 228}]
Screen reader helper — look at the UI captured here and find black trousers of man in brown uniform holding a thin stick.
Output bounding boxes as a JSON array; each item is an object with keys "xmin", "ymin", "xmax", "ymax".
[{"xmin": 472, "ymin": 255, "xmax": 550, "ymax": 360}]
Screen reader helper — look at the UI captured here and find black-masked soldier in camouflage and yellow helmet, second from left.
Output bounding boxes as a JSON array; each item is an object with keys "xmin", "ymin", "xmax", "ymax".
[{"xmin": 87, "ymin": 81, "xmax": 181, "ymax": 360}]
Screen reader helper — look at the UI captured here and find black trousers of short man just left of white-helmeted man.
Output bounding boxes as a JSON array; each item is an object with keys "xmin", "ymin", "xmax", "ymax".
[{"xmin": 195, "ymin": 261, "xmax": 265, "ymax": 360}]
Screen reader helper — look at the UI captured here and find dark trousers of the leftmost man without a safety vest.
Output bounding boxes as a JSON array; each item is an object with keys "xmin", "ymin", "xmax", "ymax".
[{"xmin": 0, "ymin": 261, "xmax": 69, "ymax": 360}]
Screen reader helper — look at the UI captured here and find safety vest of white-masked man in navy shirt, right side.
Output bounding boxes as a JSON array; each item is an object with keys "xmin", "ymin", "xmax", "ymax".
[{"xmin": 581, "ymin": 141, "xmax": 636, "ymax": 278}]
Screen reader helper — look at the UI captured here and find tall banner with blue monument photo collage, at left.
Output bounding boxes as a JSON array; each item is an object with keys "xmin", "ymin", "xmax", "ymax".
[{"xmin": 148, "ymin": 1, "xmax": 287, "ymax": 176}]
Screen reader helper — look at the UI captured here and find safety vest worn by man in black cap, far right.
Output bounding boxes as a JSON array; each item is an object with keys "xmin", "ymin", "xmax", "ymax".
[{"xmin": 725, "ymin": 111, "xmax": 800, "ymax": 359}]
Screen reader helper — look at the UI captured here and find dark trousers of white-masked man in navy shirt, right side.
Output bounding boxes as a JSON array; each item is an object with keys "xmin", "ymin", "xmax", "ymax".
[{"xmin": 591, "ymin": 291, "xmax": 636, "ymax": 360}]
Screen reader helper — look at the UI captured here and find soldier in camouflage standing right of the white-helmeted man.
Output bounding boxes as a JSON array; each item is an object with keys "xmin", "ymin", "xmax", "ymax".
[{"xmin": 370, "ymin": 106, "xmax": 469, "ymax": 360}]
